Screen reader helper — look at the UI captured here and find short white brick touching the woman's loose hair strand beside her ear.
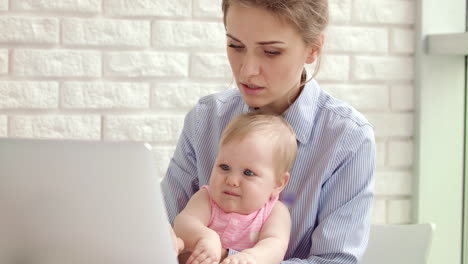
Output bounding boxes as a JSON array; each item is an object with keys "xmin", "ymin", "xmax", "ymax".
[{"xmin": 305, "ymin": 54, "xmax": 349, "ymax": 81}]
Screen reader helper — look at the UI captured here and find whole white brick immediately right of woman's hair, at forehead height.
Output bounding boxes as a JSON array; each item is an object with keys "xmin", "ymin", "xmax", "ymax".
[{"xmin": 325, "ymin": 26, "xmax": 388, "ymax": 52}]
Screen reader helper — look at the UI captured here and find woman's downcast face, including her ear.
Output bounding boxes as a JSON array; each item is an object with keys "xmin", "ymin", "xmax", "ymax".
[{"xmin": 226, "ymin": 5, "xmax": 317, "ymax": 114}]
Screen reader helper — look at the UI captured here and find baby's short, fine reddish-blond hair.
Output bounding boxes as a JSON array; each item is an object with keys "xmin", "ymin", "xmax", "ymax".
[{"xmin": 219, "ymin": 112, "xmax": 297, "ymax": 173}]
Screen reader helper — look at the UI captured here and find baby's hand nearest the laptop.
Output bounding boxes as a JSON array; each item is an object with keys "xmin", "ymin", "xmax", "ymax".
[{"xmin": 187, "ymin": 238, "xmax": 222, "ymax": 264}]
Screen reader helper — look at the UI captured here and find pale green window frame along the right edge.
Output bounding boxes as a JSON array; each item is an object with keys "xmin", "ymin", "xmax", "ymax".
[{"xmin": 413, "ymin": 0, "xmax": 468, "ymax": 264}]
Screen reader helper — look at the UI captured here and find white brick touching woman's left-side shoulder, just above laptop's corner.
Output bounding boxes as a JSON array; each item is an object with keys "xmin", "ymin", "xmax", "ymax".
[{"xmin": 104, "ymin": 115, "xmax": 184, "ymax": 144}]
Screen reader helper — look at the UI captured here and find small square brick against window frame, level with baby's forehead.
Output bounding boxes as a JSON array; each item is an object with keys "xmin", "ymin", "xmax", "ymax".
[{"xmin": 388, "ymin": 140, "xmax": 413, "ymax": 167}]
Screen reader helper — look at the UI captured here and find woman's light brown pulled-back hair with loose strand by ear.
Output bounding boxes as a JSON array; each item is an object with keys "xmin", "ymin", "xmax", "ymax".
[{"xmin": 222, "ymin": 0, "xmax": 329, "ymax": 77}]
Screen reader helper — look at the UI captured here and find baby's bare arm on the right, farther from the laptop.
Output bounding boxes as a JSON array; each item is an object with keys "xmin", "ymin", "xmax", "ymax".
[{"xmin": 223, "ymin": 202, "xmax": 291, "ymax": 264}]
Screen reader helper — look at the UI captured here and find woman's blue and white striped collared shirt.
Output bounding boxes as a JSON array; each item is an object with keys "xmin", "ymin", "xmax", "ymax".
[{"xmin": 162, "ymin": 80, "xmax": 375, "ymax": 264}]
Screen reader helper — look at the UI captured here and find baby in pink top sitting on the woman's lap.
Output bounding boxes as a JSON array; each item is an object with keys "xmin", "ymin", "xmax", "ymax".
[{"xmin": 174, "ymin": 113, "xmax": 297, "ymax": 264}]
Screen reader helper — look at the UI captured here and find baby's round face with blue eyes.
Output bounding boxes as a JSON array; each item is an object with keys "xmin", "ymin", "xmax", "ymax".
[{"xmin": 210, "ymin": 134, "xmax": 280, "ymax": 214}]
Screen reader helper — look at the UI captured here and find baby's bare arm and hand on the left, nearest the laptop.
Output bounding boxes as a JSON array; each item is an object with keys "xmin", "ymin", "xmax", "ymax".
[{"xmin": 174, "ymin": 189, "xmax": 222, "ymax": 263}]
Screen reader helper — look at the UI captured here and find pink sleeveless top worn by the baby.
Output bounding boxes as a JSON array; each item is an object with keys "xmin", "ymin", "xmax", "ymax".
[{"xmin": 202, "ymin": 185, "xmax": 278, "ymax": 251}]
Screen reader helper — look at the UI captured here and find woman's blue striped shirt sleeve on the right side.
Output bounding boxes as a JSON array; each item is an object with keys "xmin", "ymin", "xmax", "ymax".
[{"xmin": 282, "ymin": 125, "xmax": 375, "ymax": 264}]
